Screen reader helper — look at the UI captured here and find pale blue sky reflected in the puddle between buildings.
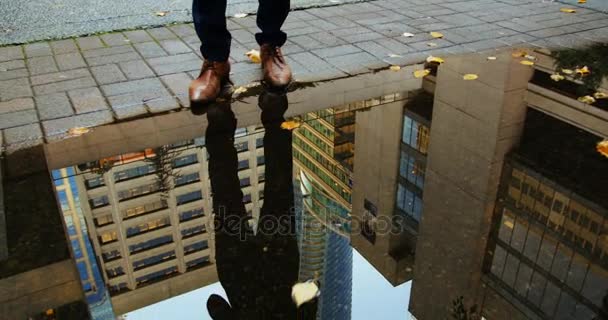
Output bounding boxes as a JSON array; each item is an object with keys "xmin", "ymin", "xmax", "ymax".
[{"xmin": 127, "ymin": 250, "xmax": 411, "ymax": 320}]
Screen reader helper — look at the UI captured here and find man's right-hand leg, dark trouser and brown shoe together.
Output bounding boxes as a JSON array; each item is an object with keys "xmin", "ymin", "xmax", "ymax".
[{"xmin": 255, "ymin": 0, "xmax": 291, "ymax": 87}]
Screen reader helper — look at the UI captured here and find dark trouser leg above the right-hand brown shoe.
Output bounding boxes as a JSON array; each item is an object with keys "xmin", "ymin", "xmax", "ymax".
[{"xmin": 255, "ymin": 0, "xmax": 289, "ymax": 47}]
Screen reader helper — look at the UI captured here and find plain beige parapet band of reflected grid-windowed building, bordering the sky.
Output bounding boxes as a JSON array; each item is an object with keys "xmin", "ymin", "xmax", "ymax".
[{"xmin": 112, "ymin": 265, "xmax": 219, "ymax": 315}]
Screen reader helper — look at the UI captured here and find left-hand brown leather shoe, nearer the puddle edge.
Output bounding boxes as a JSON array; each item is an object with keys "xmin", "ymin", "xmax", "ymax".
[{"xmin": 188, "ymin": 60, "xmax": 230, "ymax": 106}]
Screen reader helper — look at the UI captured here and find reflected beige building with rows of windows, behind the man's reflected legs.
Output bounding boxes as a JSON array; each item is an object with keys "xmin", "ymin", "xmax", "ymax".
[{"xmin": 53, "ymin": 128, "xmax": 264, "ymax": 314}]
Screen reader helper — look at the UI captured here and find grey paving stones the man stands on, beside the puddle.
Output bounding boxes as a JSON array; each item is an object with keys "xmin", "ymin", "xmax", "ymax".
[{"xmin": 0, "ymin": 0, "xmax": 608, "ymax": 152}]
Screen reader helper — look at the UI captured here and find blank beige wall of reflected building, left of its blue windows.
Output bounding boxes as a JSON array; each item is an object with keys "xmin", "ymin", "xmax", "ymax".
[{"xmin": 351, "ymin": 101, "xmax": 411, "ymax": 285}]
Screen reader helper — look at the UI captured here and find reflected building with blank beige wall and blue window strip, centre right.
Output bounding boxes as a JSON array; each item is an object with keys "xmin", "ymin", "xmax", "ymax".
[{"xmin": 351, "ymin": 93, "xmax": 422, "ymax": 286}]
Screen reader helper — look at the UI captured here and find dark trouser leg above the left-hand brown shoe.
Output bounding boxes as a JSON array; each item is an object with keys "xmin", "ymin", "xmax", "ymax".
[{"xmin": 192, "ymin": 0, "xmax": 232, "ymax": 61}]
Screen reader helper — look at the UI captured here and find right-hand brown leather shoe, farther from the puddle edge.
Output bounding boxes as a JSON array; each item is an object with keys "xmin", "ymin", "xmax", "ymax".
[{"xmin": 260, "ymin": 44, "xmax": 291, "ymax": 87}]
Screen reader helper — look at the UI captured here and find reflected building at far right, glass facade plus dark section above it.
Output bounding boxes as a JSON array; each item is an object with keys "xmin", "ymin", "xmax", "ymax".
[{"xmin": 486, "ymin": 111, "xmax": 608, "ymax": 319}]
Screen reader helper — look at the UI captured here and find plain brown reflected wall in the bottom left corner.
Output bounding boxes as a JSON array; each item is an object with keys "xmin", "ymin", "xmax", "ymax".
[{"xmin": 0, "ymin": 260, "xmax": 84, "ymax": 319}]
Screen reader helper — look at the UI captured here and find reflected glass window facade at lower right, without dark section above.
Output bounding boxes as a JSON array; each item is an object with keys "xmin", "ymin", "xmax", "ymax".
[{"xmin": 487, "ymin": 159, "xmax": 608, "ymax": 319}]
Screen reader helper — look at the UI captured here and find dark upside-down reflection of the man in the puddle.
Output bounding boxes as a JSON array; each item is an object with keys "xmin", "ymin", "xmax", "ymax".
[{"xmin": 206, "ymin": 92, "xmax": 315, "ymax": 320}]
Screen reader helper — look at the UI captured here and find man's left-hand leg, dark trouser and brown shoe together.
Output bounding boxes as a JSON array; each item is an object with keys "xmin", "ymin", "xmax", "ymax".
[{"xmin": 188, "ymin": 0, "xmax": 232, "ymax": 108}]
